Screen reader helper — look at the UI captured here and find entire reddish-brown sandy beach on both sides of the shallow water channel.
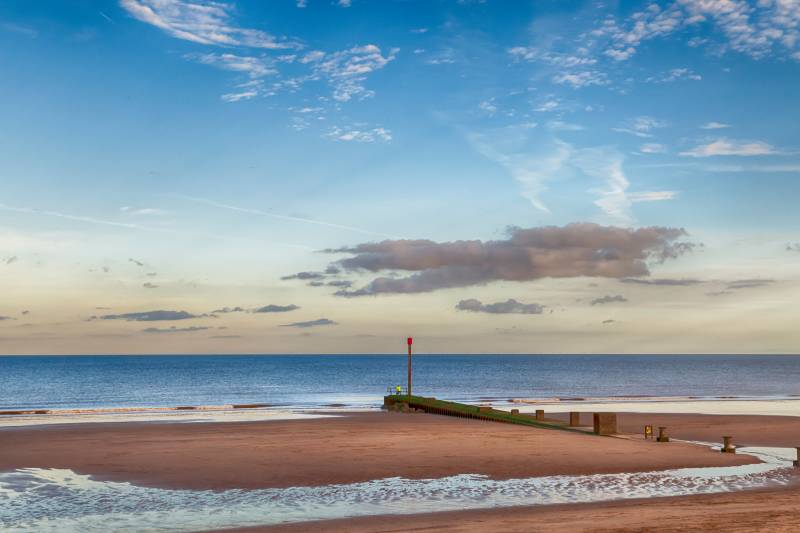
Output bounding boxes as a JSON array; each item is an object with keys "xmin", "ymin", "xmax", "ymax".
[{"xmin": 0, "ymin": 412, "xmax": 800, "ymax": 532}]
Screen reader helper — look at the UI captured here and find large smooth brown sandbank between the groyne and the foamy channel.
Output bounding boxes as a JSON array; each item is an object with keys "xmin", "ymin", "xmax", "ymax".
[{"xmin": 0, "ymin": 412, "xmax": 755, "ymax": 490}]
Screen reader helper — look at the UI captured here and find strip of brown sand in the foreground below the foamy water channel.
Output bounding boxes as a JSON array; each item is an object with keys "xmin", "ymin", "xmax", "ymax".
[{"xmin": 225, "ymin": 487, "xmax": 800, "ymax": 533}]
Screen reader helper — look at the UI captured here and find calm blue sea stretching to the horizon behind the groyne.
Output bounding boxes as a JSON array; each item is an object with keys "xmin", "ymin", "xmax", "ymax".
[{"xmin": 0, "ymin": 355, "xmax": 800, "ymax": 409}]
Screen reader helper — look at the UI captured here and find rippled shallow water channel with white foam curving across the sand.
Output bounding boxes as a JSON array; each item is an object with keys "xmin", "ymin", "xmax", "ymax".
[{"xmin": 0, "ymin": 448, "xmax": 795, "ymax": 532}]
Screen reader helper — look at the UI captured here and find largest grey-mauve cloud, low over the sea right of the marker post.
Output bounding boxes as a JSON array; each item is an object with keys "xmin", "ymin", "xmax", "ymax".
[{"xmin": 318, "ymin": 223, "xmax": 695, "ymax": 297}]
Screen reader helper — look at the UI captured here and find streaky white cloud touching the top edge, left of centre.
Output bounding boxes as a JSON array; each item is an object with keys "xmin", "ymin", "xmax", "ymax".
[{"xmin": 120, "ymin": 0, "xmax": 299, "ymax": 49}]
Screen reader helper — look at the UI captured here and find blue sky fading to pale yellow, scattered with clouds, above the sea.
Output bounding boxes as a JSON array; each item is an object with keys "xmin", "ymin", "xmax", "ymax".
[{"xmin": 0, "ymin": 0, "xmax": 800, "ymax": 354}]
